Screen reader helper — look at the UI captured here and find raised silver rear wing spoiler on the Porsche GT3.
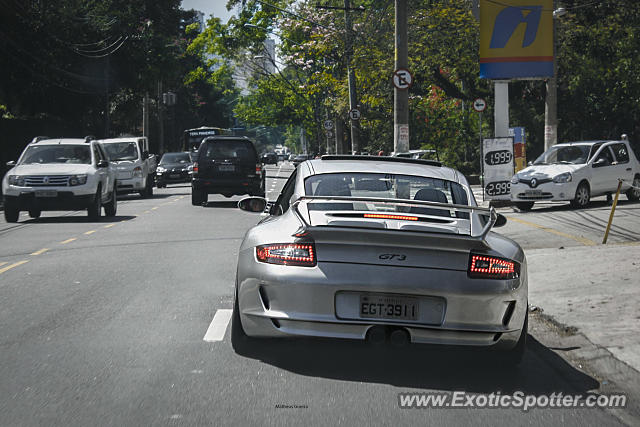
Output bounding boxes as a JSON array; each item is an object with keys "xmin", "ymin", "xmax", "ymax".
[{"xmin": 291, "ymin": 196, "xmax": 498, "ymax": 240}]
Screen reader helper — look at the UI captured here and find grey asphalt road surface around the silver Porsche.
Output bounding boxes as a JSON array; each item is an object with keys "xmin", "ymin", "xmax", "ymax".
[{"xmin": 0, "ymin": 166, "xmax": 632, "ymax": 426}]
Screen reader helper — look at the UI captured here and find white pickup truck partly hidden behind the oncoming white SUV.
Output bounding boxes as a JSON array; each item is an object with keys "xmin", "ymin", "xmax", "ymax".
[{"xmin": 99, "ymin": 136, "xmax": 157, "ymax": 197}]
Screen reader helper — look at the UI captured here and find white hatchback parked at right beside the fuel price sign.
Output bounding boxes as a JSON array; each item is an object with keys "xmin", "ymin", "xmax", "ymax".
[{"xmin": 510, "ymin": 140, "xmax": 640, "ymax": 210}]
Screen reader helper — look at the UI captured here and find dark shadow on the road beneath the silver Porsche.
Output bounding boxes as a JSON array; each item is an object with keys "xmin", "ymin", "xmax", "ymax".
[{"xmin": 234, "ymin": 335, "xmax": 599, "ymax": 395}]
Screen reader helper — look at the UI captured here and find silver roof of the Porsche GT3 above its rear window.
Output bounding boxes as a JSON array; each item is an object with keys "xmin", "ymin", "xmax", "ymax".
[{"xmin": 306, "ymin": 156, "xmax": 462, "ymax": 183}]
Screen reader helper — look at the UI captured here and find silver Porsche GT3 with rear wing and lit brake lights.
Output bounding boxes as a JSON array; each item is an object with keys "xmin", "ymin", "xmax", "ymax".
[{"xmin": 231, "ymin": 156, "xmax": 527, "ymax": 363}]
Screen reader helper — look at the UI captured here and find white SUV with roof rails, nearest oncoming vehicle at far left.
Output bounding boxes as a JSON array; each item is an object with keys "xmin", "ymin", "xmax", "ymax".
[{"xmin": 2, "ymin": 137, "xmax": 117, "ymax": 222}]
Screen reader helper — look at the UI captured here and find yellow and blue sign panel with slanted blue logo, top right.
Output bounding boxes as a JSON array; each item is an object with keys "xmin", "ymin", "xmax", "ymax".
[{"xmin": 480, "ymin": 0, "xmax": 553, "ymax": 79}]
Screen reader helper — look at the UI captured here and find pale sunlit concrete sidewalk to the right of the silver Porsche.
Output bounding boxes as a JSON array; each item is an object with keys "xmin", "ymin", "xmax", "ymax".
[{"xmin": 525, "ymin": 244, "xmax": 640, "ymax": 371}]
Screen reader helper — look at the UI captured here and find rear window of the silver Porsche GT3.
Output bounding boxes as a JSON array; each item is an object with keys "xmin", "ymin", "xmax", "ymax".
[{"xmin": 305, "ymin": 173, "xmax": 468, "ymax": 216}]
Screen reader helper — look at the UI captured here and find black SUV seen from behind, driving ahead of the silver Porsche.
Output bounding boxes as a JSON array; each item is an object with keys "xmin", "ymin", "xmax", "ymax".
[{"xmin": 191, "ymin": 135, "xmax": 265, "ymax": 205}]
